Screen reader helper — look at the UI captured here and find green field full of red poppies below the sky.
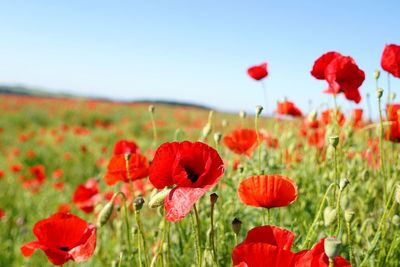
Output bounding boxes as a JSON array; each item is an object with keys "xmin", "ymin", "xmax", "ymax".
[{"xmin": 0, "ymin": 45, "xmax": 400, "ymax": 267}]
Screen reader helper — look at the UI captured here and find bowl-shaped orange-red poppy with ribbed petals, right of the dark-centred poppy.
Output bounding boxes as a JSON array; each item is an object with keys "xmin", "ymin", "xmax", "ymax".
[{"xmin": 238, "ymin": 174, "xmax": 297, "ymax": 208}]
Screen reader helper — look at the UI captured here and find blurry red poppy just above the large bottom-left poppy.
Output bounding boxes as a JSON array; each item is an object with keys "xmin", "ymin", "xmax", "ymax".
[{"xmin": 72, "ymin": 178, "xmax": 101, "ymax": 213}]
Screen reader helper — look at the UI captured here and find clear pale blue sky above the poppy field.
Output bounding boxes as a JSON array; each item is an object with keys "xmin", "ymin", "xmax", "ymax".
[{"xmin": 0, "ymin": 0, "xmax": 400, "ymax": 116}]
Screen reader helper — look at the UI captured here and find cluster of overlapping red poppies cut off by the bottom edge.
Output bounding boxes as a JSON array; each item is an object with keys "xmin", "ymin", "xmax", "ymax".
[{"xmin": 232, "ymin": 225, "xmax": 351, "ymax": 267}]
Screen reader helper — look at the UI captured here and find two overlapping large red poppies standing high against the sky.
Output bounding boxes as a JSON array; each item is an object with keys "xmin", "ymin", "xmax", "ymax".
[{"xmin": 311, "ymin": 51, "xmax": 365, "ymax": 103}]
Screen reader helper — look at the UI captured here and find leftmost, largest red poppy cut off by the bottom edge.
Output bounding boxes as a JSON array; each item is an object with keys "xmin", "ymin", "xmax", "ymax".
[{"xmin": 232, "ymin": 226, "xmax": 296, "ymax": 267}]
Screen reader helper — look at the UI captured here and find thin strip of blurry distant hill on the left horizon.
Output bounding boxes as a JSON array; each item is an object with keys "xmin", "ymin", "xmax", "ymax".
[{"xmin": 0, "ymin": 85, "xmax": 212, "ymax": 110}]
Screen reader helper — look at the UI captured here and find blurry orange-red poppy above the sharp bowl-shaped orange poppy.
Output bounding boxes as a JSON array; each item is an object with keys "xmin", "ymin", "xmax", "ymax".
[{"xmin": 223, "ymin": 129, "xmax": 258, "ymax": 157}]
